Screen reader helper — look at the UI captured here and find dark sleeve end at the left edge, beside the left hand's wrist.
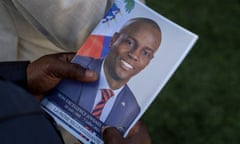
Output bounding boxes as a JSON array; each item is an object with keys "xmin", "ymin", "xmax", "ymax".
[{"xmin": 0, "ymin": 61, "xmax": 30, "ymax": 88}]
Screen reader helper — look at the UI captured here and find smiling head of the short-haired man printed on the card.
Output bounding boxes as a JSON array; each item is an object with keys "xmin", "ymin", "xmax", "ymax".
[{"xmin": 104, "ymin": 18, "xmax": 161, "ymax": 89}]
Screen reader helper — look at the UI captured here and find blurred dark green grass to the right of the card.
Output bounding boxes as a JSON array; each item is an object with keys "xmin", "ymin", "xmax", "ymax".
[{"xmin": 143, "ymin": 0, "xmax": 240, "ymax": 144}]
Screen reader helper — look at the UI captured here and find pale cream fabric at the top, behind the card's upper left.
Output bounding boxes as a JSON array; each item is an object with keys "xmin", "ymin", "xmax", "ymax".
[{"xmin": 13, "ymin": 0, "xmax": 110, "ymax": 50}]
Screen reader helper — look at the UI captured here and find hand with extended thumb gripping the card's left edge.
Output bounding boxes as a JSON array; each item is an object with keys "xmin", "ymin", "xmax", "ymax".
[{"xmin": 27, "ymin": 53, "xmax": 98, "ymax": 95}]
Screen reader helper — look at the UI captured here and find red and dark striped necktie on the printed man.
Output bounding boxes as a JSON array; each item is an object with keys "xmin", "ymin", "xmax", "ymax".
[{"xmin": 92, "ymin": 89, "xmax": 114, "ymax": 119}]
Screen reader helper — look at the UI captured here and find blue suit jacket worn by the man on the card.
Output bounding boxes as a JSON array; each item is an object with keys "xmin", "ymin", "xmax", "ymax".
[{"xmin": 55, "ymin": 56, "xmax": 140, "ymax": 132}]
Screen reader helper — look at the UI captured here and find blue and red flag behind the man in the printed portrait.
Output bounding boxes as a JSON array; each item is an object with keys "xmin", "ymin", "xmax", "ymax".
[{"xmin": 77, "ymin": 0, "xmax": 135, "ymax": 58}]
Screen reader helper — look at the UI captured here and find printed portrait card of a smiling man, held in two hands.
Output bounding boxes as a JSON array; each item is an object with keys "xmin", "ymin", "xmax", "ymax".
[{"xmin": 42, "ymin": 0, "xmax": 198, "ymax": 143}]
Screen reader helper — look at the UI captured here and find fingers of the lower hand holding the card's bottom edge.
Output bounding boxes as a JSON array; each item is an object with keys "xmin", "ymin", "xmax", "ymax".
[{"xmin": 103, "ymin": 121, "xmax": 151, "ymax": 144}]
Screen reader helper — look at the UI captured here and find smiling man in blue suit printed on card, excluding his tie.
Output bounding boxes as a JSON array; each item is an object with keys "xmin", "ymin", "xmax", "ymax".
[{"xmin": 53, "ymin": 18, "xmax": 161, "ymax": 132}]
